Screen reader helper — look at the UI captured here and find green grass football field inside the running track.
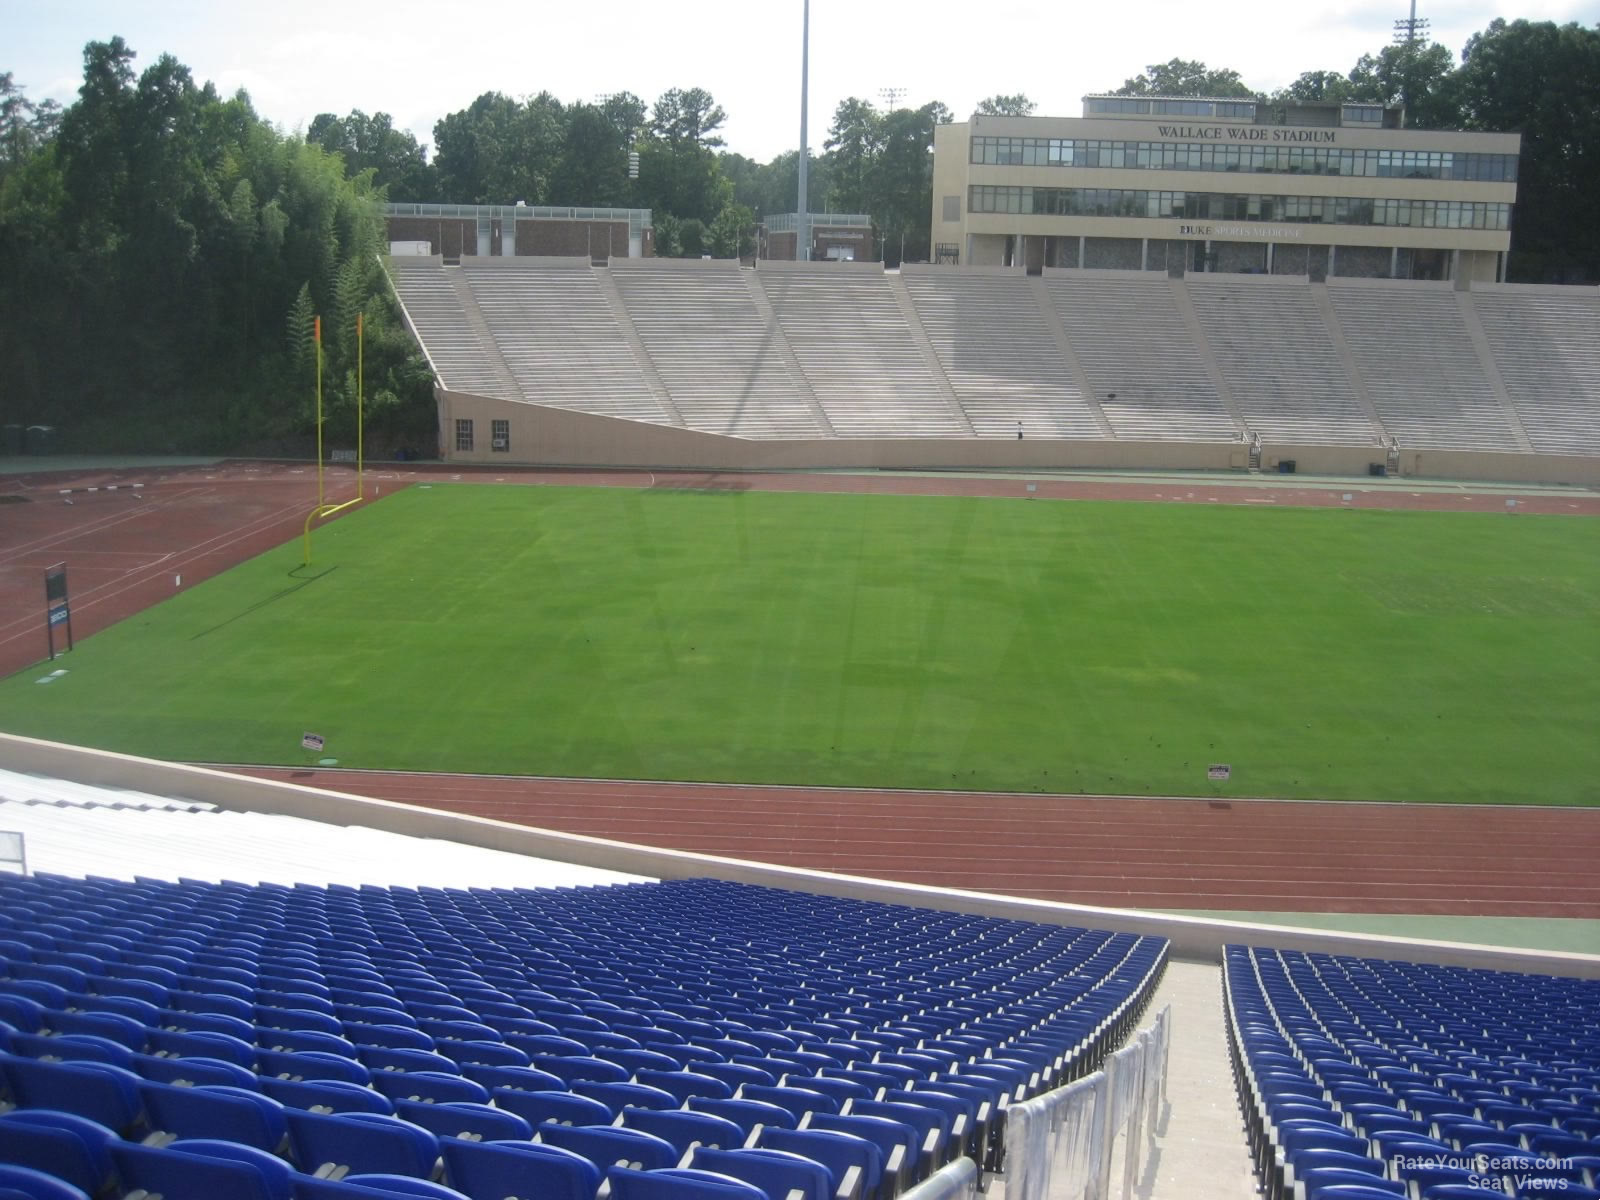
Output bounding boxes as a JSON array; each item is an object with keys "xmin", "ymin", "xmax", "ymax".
[{"xmin": 0, "ymin": 485, "xmax": 1600, "ymax": 805}]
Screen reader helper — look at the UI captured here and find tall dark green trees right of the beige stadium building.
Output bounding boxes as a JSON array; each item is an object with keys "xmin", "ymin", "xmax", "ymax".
[{"xmin": 1454, "ymin": 19, "xmax": 1600, "ymax": 283}]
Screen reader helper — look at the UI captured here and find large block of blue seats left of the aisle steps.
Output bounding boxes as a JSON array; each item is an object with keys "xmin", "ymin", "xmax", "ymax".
[{"xmin": 0, "ymin": 876, "xmax": 1166, "ymax": 1200}]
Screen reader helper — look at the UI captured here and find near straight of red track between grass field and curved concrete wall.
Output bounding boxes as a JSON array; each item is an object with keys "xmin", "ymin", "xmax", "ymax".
[{"xmin": 234, "ymin": 768, "xmax": 1600, "ymax": 918}]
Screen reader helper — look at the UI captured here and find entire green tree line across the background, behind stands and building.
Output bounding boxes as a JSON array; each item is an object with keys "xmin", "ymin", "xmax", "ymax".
[{"xmin": 0, "ymin": 21, "xmax": 1600, "ymax": 450}]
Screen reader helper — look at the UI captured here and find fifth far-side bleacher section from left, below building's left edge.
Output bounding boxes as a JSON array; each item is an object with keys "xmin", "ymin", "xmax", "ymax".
[{"xmin": 902, "ymin": 267, "xmax": 1101, "ymax": 438}]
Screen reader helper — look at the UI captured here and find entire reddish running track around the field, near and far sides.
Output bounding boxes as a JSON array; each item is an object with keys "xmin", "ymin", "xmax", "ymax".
[{"xmin": 0, "ymin": 464, "xmax": 1600, "ymax": 918}]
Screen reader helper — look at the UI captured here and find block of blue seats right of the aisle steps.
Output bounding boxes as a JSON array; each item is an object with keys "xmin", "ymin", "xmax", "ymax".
[{"xmin": 1224, "ymin": 947, "xmax": 1600, "ymax": 1200}]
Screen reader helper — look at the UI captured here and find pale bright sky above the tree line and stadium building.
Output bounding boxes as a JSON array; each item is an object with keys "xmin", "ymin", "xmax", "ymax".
[{"xmin": 0, "ymin": 0, "xmax": 1600, "ymax": 162}]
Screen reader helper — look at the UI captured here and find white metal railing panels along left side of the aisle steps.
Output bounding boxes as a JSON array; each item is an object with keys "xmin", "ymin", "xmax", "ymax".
[{"xmin": 1005, "ymin": 1005, "xmax": 1171, "ymax": 1200}]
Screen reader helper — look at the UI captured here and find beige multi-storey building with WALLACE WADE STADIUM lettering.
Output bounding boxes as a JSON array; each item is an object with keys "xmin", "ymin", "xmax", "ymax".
[{"xmin": 931, "ymin": 96, "xmax": 1522, "ymax": 283}]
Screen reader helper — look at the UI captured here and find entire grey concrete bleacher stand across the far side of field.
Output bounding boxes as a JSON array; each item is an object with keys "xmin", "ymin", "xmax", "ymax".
[{"xmin": 390, "ymin": 258, "xmax": 1600, "ymax": 483}]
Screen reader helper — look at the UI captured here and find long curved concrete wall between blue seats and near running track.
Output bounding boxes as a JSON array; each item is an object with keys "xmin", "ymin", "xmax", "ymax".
[{"xmin": 0, "ymin": 733, "xmax": 1600, "ymax": 979}]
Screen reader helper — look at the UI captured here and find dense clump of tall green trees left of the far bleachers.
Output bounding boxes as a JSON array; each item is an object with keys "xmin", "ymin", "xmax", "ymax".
[{"xmin": 0, "ymin": 38, "xmax": 434, "ymax": 453}]
